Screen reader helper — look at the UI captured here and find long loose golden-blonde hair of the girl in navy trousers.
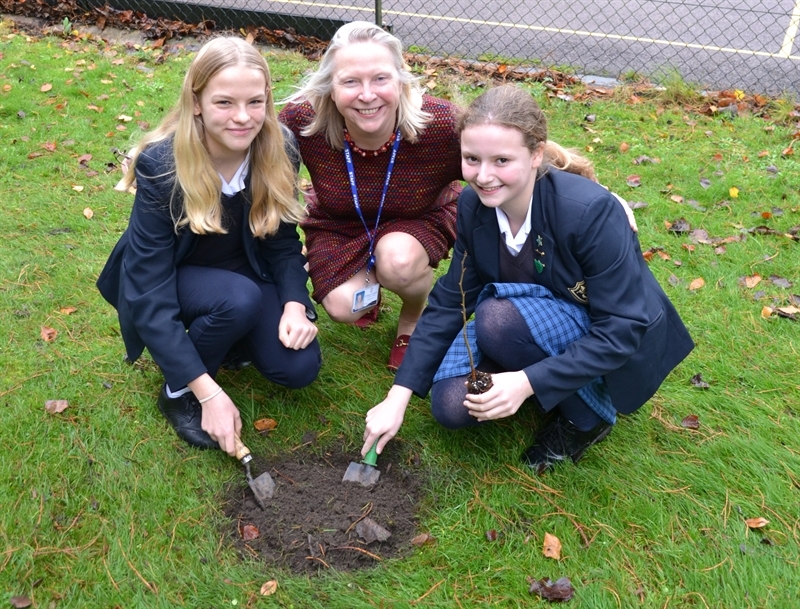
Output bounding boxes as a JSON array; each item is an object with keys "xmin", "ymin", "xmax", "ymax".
[{"xmin": 123, "ymin": 37, "xmax": 304, "ymax": 238}]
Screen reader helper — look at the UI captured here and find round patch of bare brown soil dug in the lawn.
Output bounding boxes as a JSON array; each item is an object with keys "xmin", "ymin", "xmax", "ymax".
[{"xmin": 224, "ymin": 444, "xmax": 422, "ymax": 573}]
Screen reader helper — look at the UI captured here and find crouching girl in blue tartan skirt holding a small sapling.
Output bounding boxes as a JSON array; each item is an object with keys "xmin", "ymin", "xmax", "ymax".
[{"xmin": 362, "ymin": 86, "xmax": 693, "ymax": 473}]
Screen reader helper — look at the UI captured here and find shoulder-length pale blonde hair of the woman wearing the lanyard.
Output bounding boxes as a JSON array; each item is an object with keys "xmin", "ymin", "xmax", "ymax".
[{"xmin": 281, "ymin": 21, "xmax": 431, "ymax": 150}]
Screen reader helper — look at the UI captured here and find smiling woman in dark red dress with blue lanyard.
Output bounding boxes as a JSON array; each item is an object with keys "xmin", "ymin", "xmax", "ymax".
[{"xmin": 280, "ymin": 22, "xmax": 461, "ymax": 370}]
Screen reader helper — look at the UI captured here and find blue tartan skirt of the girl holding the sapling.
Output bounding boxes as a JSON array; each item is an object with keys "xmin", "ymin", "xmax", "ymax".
[{"xmin": 433, "ymin": 283, "xmax": 617, "ymax": 425}]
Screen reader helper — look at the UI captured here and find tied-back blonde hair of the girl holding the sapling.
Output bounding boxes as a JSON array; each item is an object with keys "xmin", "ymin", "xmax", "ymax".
[{"xmin": 456, "ymin": 85, "xmax": 597, "ymax": 182}]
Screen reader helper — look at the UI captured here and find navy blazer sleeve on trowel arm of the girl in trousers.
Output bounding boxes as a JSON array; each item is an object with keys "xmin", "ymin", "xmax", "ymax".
[{"xmin": 122, "ymin": 151, "xmax": 206, "ymax": 388}]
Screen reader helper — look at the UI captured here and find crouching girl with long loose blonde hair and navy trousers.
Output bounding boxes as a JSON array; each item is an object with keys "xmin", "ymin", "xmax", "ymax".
[{"xmin": 97, "ymin": 38, "xmax": 320, "ymax": 455}]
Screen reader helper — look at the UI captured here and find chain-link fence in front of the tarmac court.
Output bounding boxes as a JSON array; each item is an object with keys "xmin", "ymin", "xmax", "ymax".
[{"xmin": 76, "ymin": 0, "xmax": 800, "ymax": 95}]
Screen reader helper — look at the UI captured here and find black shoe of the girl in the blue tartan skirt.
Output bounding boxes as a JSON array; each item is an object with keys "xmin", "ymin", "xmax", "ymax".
[{"xmin": 522, "ymin": 415, "xmax": 612, "ymax": 474}]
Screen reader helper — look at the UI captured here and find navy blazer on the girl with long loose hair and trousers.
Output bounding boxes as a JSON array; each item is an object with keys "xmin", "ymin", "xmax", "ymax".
[{"xmin": 97, "ymin": 135, "xmax": 316, "ymax": 387}]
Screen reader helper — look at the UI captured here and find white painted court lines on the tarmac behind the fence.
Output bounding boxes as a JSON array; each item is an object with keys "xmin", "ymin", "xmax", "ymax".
[{"xmin": 273, "ymin": 0, "xmax": 800, "ymax": 61}]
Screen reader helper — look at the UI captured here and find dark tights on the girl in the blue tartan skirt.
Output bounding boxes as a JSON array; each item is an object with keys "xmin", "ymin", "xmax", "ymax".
[{"xmin": 431, "ymin": 298, "xmax": 601, "ymax": 431}]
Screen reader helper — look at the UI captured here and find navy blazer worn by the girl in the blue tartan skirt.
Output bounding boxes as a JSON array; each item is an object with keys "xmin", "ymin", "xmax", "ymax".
[{"xmin": 395, "ymin": 169, "xmax": 694, "ymax": 414}]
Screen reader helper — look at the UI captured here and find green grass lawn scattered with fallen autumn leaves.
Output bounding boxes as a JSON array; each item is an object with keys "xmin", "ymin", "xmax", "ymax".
[{"xmin": 0, "ymin": 24, "xmax": 800, "ymax": 609}]
